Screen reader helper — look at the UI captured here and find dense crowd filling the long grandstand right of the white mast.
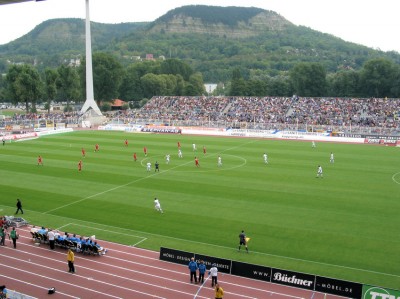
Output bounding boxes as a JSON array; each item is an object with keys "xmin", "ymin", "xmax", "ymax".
[{"xmin": 118, "ymin": 96, "xmax": 400, "ymax": 131}]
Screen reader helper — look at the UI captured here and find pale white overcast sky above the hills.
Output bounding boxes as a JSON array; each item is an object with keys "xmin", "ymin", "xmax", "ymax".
[{"xmin": 0, "ymin": 0, "xmax": 400, "ymax": 53}]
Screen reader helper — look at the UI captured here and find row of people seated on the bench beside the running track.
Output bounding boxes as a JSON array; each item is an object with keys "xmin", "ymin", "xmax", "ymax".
[{"xmin": 31, "ymin": 226, "xmax": 107, "ymax": 255}]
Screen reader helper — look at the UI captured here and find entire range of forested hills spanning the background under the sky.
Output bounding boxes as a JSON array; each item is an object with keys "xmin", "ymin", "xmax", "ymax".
[{"xmin": 0, "ymin": 5, "xmax": 400, "ymax": 82}]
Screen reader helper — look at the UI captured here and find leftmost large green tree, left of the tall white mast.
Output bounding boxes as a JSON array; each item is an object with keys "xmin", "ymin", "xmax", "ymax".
[{"xmin": 6, "ymin": 65, "xmax": 43, "ymax": 113}]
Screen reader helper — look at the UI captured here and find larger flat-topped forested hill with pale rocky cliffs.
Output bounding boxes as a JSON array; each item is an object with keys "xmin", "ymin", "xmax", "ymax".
[{"xmin": 115, "ymin": 5, "xmax": 400, "ymax": 82}]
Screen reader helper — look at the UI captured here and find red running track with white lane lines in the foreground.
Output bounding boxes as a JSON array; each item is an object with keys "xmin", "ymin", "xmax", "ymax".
[{"xmin": 0, "ymin": 227, "xmax": 342, "ymax": 299}]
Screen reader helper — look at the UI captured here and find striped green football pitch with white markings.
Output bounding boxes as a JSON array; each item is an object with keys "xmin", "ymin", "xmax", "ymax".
[{"xmin": 0, "ymin": 131, "xmax": 400, "ymax": 289}]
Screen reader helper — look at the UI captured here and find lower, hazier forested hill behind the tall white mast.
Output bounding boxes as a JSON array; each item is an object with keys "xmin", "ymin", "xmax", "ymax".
[{"xmin": 0, "ymin": 19, "xmax": 147, "ymax": 68}]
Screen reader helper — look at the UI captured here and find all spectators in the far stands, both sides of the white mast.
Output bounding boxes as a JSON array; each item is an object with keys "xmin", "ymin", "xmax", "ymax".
[{"xmin": 0, "ymin": 96, "xmax": 400, "ymax": 134}]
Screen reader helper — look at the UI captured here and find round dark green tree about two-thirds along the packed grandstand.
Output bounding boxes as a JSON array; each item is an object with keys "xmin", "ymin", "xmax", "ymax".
[{"xmin": 290, "ymin": 62, "xmax": 327, "ymax": 97}]
